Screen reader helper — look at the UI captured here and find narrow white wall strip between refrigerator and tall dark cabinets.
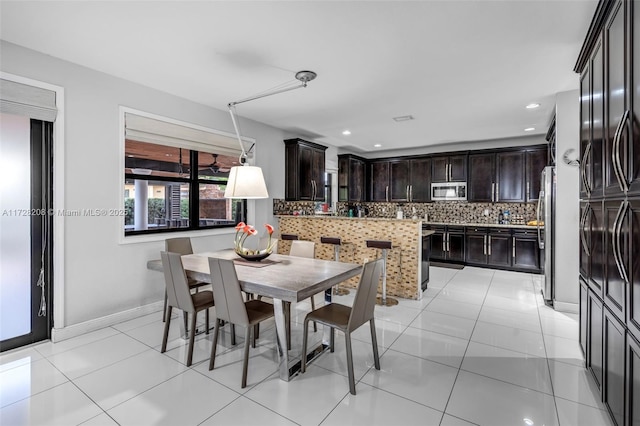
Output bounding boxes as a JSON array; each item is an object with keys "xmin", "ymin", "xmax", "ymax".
[{"xmin": 554, "ymin": 90, "xmax": 580, "ymax": 312}]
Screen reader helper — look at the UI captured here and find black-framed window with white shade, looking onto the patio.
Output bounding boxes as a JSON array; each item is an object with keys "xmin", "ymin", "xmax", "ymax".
[{"xmin": 123, "ymin": 114, "xmax": 246, "ymax": 235}]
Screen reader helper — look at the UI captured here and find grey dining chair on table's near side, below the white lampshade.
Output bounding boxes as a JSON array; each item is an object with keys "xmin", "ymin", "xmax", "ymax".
[{"xmin": 209, "ymin": 258, "xmax": 273, "ymax": 388}]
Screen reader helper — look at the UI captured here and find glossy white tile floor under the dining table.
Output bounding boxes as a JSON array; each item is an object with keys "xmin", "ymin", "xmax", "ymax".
[{"xmin": 0, "ymin": 267, "xmax": 611, "ymax": 426}]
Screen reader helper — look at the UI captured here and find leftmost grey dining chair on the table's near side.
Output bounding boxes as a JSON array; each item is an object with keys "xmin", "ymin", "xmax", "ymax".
[{"xmin": 160, "ymin": 251, "xmax": 217, "ymax": 367}]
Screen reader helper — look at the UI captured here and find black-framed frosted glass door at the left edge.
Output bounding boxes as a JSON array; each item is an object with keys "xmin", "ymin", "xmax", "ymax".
[{"xmin": 0, "ymin": 114, "xmax": 53, "ymax": 351}]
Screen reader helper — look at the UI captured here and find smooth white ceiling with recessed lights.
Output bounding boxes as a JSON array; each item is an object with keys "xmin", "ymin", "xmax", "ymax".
[{"xmin": 0, "ymin": 0, "xmax": 597, "ymax": 154}]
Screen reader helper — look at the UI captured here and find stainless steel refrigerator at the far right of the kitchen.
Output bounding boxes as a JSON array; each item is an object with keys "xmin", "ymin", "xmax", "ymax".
[{"xmin": 536, "ymin": 166, "xmax": 557, "ymax": 305}]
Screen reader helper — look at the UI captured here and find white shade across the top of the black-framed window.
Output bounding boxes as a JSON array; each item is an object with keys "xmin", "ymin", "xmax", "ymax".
[{"xmin": 125, "ymin": 113, "xmax": 241, "ymax": 156}]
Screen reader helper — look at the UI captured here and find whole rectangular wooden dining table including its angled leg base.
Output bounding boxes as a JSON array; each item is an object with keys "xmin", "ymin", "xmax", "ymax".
[{"xmin": 147, "ymin": 249, "xmax": 362, "ymax": 381}]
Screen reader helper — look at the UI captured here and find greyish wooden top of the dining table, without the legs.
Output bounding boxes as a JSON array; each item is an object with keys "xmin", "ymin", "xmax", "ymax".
[{"xmin": 147, "ymin": 249, "xmax": 362, "ymax": 302}]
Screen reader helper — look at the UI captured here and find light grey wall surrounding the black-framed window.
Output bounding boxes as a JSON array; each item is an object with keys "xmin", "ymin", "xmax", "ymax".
[{"xmin": 0, "ymin": 41, "xmax": 285, "ymax": 329}]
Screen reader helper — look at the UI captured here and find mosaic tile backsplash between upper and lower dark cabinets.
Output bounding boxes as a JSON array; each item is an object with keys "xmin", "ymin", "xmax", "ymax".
[{"xmin": 273, "ymin": 199, "xmax": 536, "ymax": 223}]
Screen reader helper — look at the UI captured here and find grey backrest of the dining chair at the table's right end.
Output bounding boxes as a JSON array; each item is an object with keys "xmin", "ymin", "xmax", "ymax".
[{"xmin": 347, "ymin": 259, "xmax": 383, "ymax": 331}]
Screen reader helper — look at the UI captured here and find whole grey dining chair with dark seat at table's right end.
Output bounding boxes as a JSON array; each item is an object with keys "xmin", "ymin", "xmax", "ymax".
[{"xmin": 300, "ymin": 259, "xmax": 382, "ymax": 395}]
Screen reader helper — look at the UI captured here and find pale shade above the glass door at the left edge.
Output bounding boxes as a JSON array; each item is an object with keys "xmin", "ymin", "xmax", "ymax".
[{"xmin": 0, "ymin": 79, "xmax": 58, "ymax": 122}]
